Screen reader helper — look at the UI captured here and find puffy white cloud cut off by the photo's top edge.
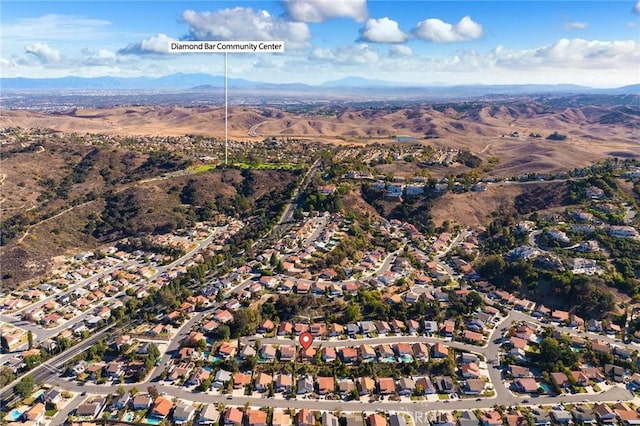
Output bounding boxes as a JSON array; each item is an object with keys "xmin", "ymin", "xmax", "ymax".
[{"xmin": 284, "ymin": 0, "xmax": 368, "ymax": 22}]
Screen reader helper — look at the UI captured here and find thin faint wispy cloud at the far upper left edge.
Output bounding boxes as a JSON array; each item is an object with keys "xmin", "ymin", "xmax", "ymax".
[{"xmin": 0, "ymin": 14, "xmax": 110, "ymax": 42}]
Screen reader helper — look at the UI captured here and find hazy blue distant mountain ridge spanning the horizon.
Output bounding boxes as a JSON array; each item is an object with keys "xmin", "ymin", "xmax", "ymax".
[{"xmin": 0, "ymin": 73, "xmax": 640, "ymax": 95}]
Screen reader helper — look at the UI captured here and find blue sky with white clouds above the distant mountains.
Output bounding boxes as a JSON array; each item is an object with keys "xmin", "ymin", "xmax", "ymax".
[{"xmin": 0, "ymin": 0, "xmax": 640, "ymax": 87}]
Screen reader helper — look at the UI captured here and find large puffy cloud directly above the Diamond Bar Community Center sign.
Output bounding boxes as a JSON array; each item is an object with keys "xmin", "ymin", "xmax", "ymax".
[{"xmin": 182, "ymin": 7, "xmax": 311, "ymax": 49}]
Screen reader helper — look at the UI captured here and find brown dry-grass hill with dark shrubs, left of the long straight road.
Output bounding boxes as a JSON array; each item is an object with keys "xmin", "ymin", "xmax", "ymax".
[{"xmin": 0, "ymin": 135, "xmax": 297, "ymax": 286}]
